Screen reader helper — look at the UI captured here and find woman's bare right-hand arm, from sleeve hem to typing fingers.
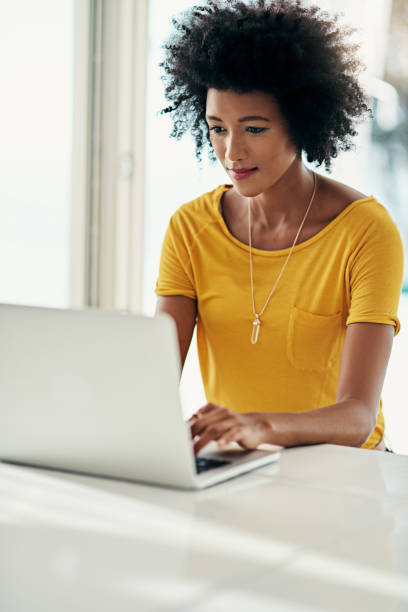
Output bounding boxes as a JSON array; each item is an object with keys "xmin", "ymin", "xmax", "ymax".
[{"xmin": 191, "ymin": 323, "xmax": 394, "ymax": 452}]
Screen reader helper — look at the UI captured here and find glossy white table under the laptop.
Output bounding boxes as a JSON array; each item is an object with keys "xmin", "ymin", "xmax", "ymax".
[{"xmin": 0, "ymin": 445, "xmax": 408, "ymax": 612}]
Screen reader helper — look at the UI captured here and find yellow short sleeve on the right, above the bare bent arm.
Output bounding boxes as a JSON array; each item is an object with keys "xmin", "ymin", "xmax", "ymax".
[{"xmin": 346, "ymin": 209, "xmax": 404, "ymax": 335}]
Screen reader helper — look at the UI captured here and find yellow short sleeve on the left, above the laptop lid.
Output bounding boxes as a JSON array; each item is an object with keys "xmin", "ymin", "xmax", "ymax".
[{"xmin": 155, "ymin": 215, "xmax": 196, "ymax": 299}]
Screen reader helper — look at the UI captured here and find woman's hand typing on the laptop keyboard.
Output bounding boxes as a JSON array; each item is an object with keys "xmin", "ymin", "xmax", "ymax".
[{"xmin": 189, "ymin": 403, "xmax": 269, "ymax": 455}]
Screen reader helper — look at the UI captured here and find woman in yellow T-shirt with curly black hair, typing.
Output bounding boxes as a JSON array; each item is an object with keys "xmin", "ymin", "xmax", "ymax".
[{"xmin": 156, "ymin": 0, "xmax": 403, "ymax": 453}]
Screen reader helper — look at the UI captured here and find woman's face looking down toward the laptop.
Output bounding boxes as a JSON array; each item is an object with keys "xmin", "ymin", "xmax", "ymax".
[{"xmin": 206, "ymin": 88, "xmax": 298, "ymax": 197}]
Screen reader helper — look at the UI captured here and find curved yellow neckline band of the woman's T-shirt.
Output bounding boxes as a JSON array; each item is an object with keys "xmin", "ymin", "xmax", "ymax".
[{"xmin": 215, "ymin": 183, "xmax": 375, "ymax": 257}]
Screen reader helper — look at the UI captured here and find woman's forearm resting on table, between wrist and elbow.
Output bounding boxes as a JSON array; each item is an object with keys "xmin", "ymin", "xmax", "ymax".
[{"xmin": 263, "ymin": 399, "xmax": 375, "ymax": 446}]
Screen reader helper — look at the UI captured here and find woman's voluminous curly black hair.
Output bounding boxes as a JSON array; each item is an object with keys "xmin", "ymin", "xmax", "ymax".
[{"xmin": 160, "ymin": 0, "xmax": 372, "ymax": 171}]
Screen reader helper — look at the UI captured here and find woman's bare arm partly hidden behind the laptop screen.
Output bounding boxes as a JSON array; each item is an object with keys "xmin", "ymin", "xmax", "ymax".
[{"xmin": 156, "ymin": 295, "xmax": 197, "ymax": 371}]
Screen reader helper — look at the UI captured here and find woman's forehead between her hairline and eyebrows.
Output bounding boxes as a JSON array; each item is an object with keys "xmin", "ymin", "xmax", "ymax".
[{"xmin": 206, "ymin": 88, "xmax": 279, "ymax": 119}]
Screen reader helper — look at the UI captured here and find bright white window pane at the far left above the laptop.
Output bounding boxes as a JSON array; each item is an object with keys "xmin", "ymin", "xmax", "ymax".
[{"xmin": 0, "ymin": 0, "xmax": 74, "ymax": 306}]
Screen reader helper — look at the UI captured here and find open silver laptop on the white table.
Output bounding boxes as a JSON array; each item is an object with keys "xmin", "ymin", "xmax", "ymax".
[{"xmin": 0, "ymin": 304, "xmax": 279, "ymax": 489}]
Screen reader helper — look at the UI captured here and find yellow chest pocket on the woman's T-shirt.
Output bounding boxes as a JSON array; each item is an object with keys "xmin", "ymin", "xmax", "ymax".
[{"xmin": 287, "ymin": 306, "xmax": 342, "ymax": 372}]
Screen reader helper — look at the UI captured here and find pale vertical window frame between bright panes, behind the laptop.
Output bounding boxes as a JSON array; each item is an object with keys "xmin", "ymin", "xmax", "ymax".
[{"xmin": 70, "ymin": 0, "xmax": 148, "ymax": 311}]
